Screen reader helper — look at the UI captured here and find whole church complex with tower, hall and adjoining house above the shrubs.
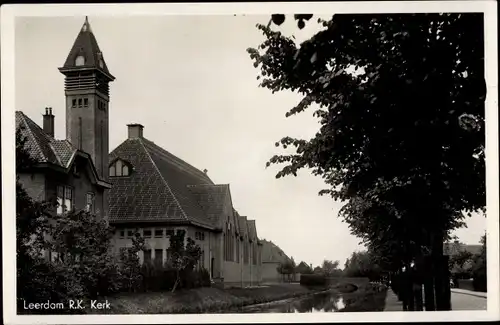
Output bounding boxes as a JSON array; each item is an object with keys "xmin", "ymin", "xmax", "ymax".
[{"xmin": 16, "ymin": 18, "xmax": 262, "ymax": 286}]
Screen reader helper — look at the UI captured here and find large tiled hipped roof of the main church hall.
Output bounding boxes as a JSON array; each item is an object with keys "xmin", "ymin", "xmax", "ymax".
[{"xmin": 109, "ymin": 137, "xmax": 236, "ymax": 229}]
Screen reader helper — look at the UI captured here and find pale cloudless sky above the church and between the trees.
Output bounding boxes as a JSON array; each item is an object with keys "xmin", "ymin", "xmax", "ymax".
[{"xmin": 15, "ymin": 15, "xmax": 486, "ymax": 266}]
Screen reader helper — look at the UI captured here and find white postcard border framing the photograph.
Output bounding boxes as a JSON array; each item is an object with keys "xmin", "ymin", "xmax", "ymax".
[{"xmin": 1, "ymin": 1, "xmax": 500, "ymax": 324}]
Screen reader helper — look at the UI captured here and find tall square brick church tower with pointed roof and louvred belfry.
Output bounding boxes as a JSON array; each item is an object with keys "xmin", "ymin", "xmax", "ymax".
[{"xmin": 59, "ymin": 17, "xmax": 115, "ymax": 180}]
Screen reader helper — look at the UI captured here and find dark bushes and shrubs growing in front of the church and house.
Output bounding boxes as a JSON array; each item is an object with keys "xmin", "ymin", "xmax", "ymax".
[{"xmin": 16, "ymin": 130, "xmax": 210, "ymax": 312}]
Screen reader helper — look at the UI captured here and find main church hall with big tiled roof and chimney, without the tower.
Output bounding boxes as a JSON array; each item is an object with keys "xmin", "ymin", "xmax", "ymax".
[{"xmin": 108, "ymin": 124, "xmax": 261, "ymax": 286}]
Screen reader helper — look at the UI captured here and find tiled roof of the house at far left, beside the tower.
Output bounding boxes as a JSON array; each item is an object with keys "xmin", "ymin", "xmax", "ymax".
[{"xmin": 16, "ymin": 111, "xmax": 77, "ymax": 168}]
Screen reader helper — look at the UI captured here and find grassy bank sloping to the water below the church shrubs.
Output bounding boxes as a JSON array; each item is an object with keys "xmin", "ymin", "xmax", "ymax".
[{"xmin": 92, "ymin": 284, "xmax": 323, "ymax": 314}]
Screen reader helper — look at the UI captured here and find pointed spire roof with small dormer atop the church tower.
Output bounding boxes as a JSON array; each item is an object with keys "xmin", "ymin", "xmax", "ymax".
[{"xmin": 60, "ymin": 17, "xmax": 114, "ymax": 79}]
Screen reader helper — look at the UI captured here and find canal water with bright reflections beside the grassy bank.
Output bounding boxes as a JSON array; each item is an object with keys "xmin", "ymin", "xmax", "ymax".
[{"xmin": 241, "ymin": 292, "xmax": 345, "ymax": 313}]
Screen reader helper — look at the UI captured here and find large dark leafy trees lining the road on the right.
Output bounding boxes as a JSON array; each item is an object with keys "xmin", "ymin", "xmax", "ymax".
[{"xmin": 252, "ymin": 13, "xmax": 486, "ymax": 310}]
